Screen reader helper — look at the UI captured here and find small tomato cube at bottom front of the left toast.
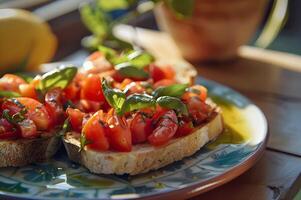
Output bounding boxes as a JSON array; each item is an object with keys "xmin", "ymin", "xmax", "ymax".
[{"xmin": 18, "ymin": 119, "xmax": 40, "ymax": 138}]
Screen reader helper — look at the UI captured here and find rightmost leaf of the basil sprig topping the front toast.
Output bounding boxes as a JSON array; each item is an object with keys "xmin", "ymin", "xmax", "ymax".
[{"xmin": 156, "ymin": 96, "xmax": 188, "ymax": 116}]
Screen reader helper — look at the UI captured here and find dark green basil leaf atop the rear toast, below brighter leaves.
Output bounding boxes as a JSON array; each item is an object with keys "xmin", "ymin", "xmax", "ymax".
[{"xmin": 115, "ymin": 62, "xmax": 149, "ymax": 79}]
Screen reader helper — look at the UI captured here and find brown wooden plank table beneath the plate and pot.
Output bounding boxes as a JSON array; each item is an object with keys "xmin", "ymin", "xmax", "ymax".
[{"xmin": 56, "ymin": 27, "xmax": 301, "ymax": 200}]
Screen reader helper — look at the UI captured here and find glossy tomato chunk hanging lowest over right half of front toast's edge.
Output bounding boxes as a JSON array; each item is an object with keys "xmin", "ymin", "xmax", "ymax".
[{"xmin": 147, "ymin": 110, "xmax": 178, "ymax": 146}]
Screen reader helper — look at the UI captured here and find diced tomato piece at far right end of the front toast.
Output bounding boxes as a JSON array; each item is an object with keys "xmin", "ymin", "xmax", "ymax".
[{"xmin": 187, "ymin": 97, "xmax": 209, "ymax": 125}]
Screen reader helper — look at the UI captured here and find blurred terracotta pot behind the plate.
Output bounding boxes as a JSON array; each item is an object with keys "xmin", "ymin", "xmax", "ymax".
[{"xmin": 155, "ymin": 0, "xmax": 268, "ymax": 61}]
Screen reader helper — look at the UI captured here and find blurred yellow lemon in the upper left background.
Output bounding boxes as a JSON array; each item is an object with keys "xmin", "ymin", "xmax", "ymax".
[{"xmin": 0, "ymin": 9, "xmax": 57, "ymax": 73}]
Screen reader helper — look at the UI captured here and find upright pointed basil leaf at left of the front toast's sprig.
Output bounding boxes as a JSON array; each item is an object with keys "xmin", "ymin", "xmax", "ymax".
[{"xmin": 101, "ymin": 79, "xmax": 126, "ymax": 115}]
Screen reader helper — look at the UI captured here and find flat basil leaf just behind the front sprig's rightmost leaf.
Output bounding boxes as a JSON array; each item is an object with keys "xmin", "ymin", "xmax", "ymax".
[{"xmin": 152, "ymin": 84, "xmax": 188, "ymax": 98}]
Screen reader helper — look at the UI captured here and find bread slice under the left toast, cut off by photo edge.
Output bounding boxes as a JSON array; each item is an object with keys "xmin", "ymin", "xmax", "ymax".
[{"xmin": 0, "ymin": 135, "xmax": 61, "ymax": 167}]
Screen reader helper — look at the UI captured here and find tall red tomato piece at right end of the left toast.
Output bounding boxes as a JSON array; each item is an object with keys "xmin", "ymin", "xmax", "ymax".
[{"xmin": 45, "ymin": 88, "xmax": 66, "ymax": 126}]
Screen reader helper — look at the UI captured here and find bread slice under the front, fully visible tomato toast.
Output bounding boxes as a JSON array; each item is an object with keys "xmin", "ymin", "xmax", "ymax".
[{"xmin": 63, "ymin": 109, "xmax": 223, "ymax": 175}]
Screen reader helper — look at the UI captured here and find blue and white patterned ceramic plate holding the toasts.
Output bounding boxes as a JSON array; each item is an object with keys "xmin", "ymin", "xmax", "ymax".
[{"xmin": 0, "ymin": 79, "xmax": 267, "ymax": 200}]
